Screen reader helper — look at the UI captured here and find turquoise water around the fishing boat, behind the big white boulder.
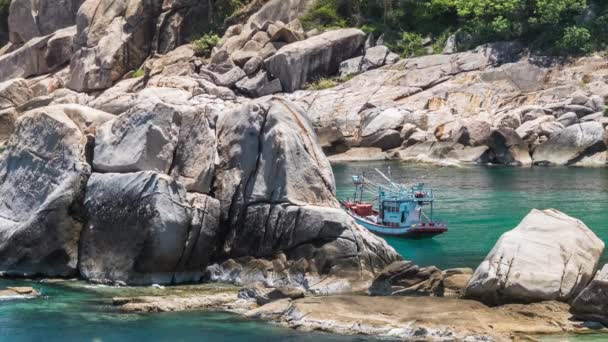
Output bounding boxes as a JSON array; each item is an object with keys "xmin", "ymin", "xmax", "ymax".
[{"xmin": 334, "ymin": 162, "xmax": 608, "ymax": 268}]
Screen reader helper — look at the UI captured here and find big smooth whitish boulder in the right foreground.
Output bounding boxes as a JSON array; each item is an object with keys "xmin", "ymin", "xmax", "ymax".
[{"xmin": 465, "ymin": 209, "xmax": 604, "ymax": 305}]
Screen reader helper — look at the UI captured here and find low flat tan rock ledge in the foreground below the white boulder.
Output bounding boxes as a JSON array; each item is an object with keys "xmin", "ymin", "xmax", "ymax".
[{"xmin": 245, "ymin": 296, "xmax": 580, "ymax": 341}]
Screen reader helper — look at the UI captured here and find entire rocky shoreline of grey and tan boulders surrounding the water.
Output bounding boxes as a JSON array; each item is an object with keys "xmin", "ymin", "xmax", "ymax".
[{"xmin": 0, "ymin": 0, "xmax": 608, "ymax": 340}]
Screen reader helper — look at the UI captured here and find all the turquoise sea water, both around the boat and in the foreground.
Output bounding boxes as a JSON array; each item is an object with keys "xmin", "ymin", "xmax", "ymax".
[{"xmin": 0, "ymin": 162, "xmax": 608, "ymax": 342}]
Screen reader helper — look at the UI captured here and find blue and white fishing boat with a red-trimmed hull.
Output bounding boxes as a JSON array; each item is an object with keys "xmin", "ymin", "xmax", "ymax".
[{"xmin": 340, "ymin": 169, "xmax": 448, "ymax": 239}]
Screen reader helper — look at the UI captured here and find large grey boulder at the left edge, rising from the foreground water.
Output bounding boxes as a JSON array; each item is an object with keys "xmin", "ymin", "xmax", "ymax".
[{"xmin": 0, "ymin": 108, "xmax": 90, "ymax": 277}]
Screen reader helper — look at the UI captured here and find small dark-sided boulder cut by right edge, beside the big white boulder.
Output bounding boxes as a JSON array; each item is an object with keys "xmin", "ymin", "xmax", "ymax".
[{"xmin": 570, "ymin": 265, "xmax": 608, "ymax": 326}]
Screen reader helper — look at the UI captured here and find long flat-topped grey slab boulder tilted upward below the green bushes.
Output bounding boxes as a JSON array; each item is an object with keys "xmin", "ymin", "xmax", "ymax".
[{"xmin": 266, "ymin": 29, "xmax": 365, "ymax": 92}]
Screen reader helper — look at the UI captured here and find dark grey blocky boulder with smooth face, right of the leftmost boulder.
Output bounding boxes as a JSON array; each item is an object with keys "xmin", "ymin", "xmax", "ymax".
[{"xmin": 79, "ymin": 172, "xmax": 219, "ymax": 285}]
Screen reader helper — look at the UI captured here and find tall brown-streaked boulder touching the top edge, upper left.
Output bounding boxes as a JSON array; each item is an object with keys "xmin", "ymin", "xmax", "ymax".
[{"xmin": 67, "ymin": 0, "xmax": 161, "ymax": 92}]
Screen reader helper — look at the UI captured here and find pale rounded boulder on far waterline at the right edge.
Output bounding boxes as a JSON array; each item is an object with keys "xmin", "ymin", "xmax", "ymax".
[{"xmin": 533, "ymin": 122, "xmax": 608, "ymax": 165}]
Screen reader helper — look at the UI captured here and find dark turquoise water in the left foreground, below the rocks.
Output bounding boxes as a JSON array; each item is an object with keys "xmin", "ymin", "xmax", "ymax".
[{"xmin": 0, "ymin": 279, "xmax": 378, "ymax": 342}]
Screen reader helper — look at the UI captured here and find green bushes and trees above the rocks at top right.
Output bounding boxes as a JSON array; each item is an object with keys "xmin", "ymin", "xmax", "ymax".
[{"xmin": 302, "ymin": 0, "xmax": 608, "ymax": 56}]
